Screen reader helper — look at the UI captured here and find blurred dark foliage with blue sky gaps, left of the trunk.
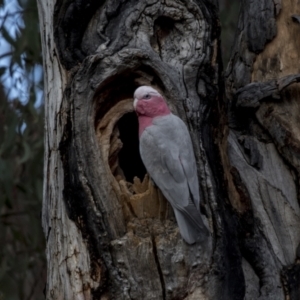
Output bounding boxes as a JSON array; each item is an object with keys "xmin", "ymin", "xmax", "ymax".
[{"xmin": 0, "ymin": 0, "xmax": 46, "ymax": 300}]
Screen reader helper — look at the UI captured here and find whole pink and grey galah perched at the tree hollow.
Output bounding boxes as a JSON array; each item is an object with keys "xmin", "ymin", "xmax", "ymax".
[{"xmin": 133, "ymin": 86, "xmax": 209, "ymax": 244}]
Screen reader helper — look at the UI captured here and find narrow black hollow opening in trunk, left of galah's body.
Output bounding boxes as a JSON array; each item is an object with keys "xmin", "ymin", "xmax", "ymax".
[{"xmin": 118, "ymin": 112, "xmax": 147, "ymax": 182}]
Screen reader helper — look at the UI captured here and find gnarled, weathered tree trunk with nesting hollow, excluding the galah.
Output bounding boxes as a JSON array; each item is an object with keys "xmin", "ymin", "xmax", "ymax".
[{"xmin": 38, "ymin": 0, "xmax": 300, "ymax": 300}]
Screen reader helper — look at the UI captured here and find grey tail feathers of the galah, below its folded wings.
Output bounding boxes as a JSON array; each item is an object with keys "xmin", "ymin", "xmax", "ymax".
[{"xmin": 174, "ymin": 206, "xmax": 209, "ymax": 244}]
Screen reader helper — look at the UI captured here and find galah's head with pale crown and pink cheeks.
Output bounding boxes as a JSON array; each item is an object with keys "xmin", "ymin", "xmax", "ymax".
[{"xmin": 133, "ymin": 85, "xmax": 170, "ymax": 118}]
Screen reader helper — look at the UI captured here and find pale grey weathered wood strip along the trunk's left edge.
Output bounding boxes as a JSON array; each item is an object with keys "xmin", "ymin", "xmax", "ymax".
[{"xmin": 38, "ymin": 1, "xmax": 100, "ymax": 300}]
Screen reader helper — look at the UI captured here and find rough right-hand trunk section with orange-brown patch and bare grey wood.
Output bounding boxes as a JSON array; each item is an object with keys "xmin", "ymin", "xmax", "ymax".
[{"xmin": 225, "ymin": 1, "xmax": 300, "ymax": 299}]
